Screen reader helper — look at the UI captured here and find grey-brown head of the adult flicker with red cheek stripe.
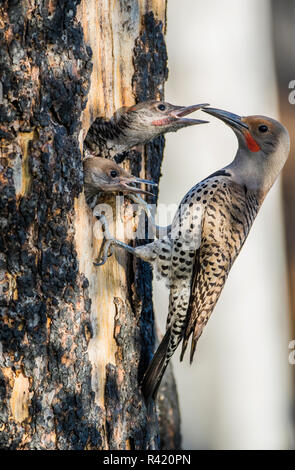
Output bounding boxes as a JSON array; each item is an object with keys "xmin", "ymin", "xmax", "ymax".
[{"xmin": 203, "ymin": 108, "xmax": 290, "ymax": 195}]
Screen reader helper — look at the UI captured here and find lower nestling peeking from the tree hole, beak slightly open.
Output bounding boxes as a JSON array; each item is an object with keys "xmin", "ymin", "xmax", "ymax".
[{"xmin": 83, "ymin": 157, "xmax": 157, "ymax": 202}]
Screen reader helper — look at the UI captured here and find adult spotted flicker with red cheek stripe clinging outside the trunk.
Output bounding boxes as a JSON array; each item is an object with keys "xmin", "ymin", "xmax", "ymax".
[{"xmin": 95, "ymin": 108, "xmax": 290, "ymax": 399}]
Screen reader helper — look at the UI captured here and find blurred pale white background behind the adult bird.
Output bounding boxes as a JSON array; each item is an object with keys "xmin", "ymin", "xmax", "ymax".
[{"xmin": 154, "ymin": 0, "xmax": 295, "ymax": 449}]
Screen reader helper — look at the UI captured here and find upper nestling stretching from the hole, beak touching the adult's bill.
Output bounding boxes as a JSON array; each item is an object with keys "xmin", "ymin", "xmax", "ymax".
[{"xmin": 84, "ymin": 101, "xmax": 207, "ymax": 158}]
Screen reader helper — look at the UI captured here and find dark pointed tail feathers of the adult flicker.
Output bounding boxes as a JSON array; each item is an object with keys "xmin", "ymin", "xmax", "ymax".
[{"xmin": 141, "ymin": 328, "xmax": 171, "ymax": 402}]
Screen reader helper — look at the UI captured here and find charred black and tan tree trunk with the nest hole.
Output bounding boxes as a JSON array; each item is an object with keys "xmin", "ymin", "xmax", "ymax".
[{"xmin": 0, "ymin": 0, "xmax": 180, "ymax": 449}]
